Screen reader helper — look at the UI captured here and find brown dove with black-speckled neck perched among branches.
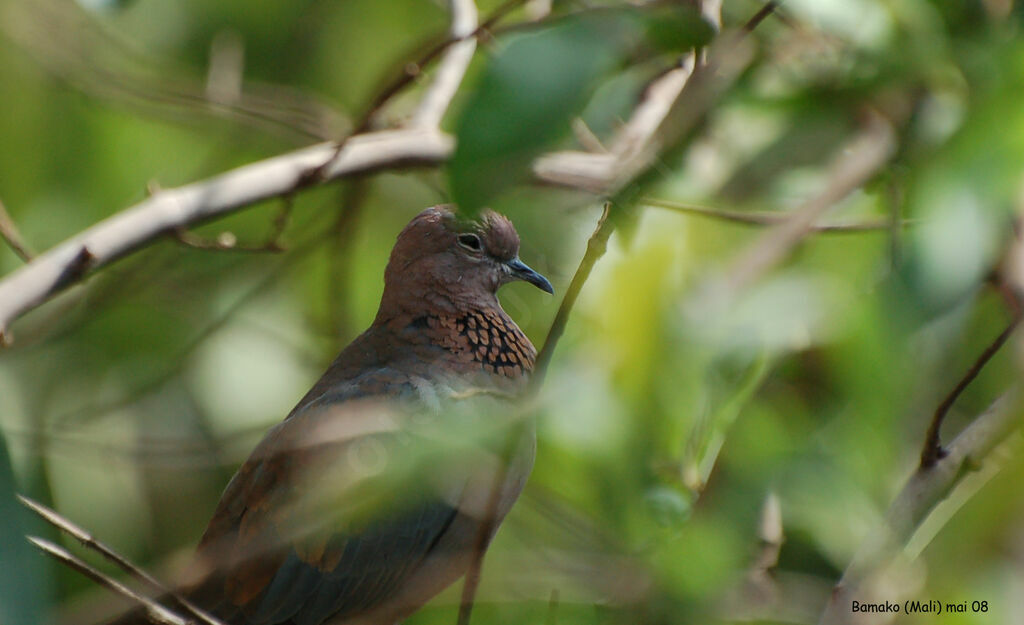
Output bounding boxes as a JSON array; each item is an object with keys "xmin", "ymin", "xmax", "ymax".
[{"xmin": 107, "ymin": 207, "xmax": 552, "ymax": 625}]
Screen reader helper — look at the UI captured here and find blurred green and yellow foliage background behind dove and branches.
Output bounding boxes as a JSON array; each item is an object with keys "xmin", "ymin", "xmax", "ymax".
[{"xmin": 0, "ymin": 0, "xmax": 1024, "ymax": 625}]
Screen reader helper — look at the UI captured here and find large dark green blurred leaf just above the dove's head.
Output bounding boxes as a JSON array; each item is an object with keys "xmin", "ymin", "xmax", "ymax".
[{"xmin": 449, "ymin": 6, "xmax": 713, "ymax": 214}]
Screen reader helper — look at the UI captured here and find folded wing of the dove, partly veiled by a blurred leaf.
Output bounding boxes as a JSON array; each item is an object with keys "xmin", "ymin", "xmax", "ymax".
[{"xmin": 194, "ymin": 372, "xmax": 479, "ymax": 625}]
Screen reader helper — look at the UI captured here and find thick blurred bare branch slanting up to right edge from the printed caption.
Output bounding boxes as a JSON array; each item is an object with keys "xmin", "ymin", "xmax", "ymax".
[{"xmin": 818, "ymin": 391, "xmax": 1021, "ymax": 625}]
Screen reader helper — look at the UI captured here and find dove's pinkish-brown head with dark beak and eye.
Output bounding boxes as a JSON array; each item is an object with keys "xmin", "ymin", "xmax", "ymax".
[{"xmin": 378, "ymin": 206, "xmax": 554, "ymax": 318}]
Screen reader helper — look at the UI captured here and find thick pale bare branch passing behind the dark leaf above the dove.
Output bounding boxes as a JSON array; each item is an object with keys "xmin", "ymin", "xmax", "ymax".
[{"xmin": 0, "ymin": 0, "xmax": 761, "ymax": 348}]
